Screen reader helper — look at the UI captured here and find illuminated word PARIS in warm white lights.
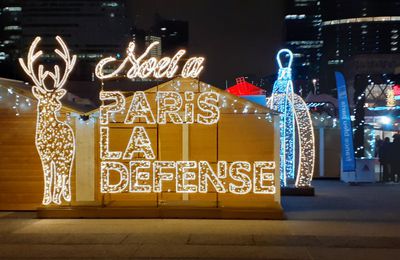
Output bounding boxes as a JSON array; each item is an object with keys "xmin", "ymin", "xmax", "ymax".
[{"xmin": 100, "ymin": 91, "xmax": 220, "ymax": 125}]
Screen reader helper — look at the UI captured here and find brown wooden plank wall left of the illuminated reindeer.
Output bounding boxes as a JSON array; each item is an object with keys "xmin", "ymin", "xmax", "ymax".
[{"xmin": 0, "ymin": 107, "xmax": 43, "ymax": 210}]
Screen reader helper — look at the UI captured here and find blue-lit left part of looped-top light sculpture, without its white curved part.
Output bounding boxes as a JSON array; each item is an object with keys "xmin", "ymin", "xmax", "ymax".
[{"xmin": 268, "ymin": 49, "xmax": 295, "ymax": 186}]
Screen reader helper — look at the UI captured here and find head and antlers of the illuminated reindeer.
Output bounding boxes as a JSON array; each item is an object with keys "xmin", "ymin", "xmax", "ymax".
[{"xmin": 19, "ymin": 36, "xmax": 76, "ymax": 112}]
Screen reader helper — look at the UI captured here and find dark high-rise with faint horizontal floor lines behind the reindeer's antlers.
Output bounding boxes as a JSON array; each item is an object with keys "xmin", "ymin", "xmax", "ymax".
[{"xmin": 21, "ymin": 0, "xmax": 129, "ymax": 80}]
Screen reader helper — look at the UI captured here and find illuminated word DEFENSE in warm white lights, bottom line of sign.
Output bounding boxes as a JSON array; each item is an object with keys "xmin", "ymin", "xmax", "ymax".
[{"xmin": 100, "ymin": 160, "xmax": 276, "ymax": 195}]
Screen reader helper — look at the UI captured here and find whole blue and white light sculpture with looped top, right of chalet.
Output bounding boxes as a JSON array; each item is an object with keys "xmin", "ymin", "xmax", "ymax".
[{"xmin": 267, "ymin": 49, "xmax": 315, "ymax": 187}]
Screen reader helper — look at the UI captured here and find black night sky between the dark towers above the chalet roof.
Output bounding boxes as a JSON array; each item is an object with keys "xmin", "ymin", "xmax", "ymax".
[{"xmin": 127, "ymin": 0, "xmax": 285, "ymax": 88}]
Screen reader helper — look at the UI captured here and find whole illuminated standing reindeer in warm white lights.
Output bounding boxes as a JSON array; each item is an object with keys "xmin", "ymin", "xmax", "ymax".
[{"xmin": 19, "ymin": 36, "xmax": 76, "ymax": 205}]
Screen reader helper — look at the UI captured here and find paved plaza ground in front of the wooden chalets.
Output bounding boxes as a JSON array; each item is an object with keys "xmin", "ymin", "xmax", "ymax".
[{"xmin": 0, "ymin": 181, "xmax": 400, "ymax": 260}]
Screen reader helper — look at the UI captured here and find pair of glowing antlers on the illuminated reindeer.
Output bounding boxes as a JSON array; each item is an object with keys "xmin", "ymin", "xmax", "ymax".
[{"xmin": 18, "ymin": 36, "xmax": 76, "ymax": 90}]
